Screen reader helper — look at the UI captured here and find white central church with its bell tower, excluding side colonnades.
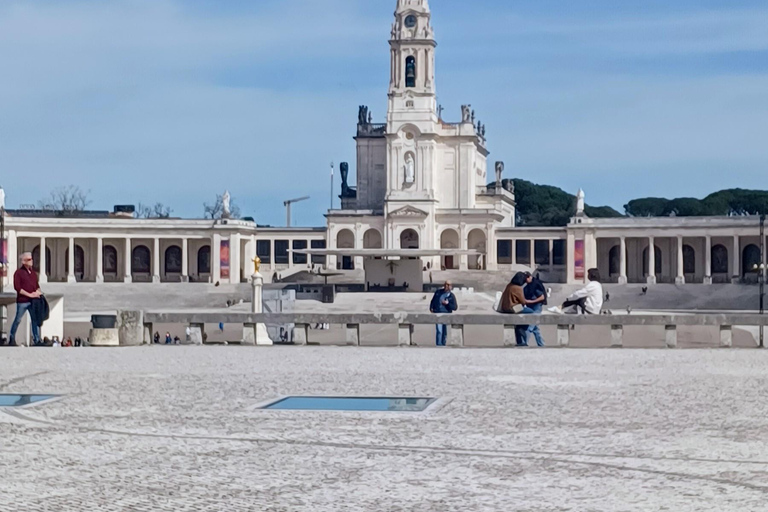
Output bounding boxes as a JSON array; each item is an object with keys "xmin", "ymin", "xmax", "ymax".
[{"xmin": 327, "ymin": 0, "xmax": 515, "ymax": 270}]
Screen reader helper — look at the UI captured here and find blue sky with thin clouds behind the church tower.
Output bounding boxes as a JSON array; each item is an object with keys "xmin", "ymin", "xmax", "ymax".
[{"xmin": 0, "ymin": 0, "xmax": 768, "ymax": 225}]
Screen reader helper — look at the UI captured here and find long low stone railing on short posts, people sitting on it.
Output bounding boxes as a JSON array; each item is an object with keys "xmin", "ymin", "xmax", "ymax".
[{"xmin": 118, "ymin": 311, "xmax": 768, "ymax": 348}]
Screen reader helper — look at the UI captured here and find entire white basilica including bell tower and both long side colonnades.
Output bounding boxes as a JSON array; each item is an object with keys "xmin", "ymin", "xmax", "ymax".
[{"xmin": 2, "ymin": 0, "xmax": 766, "ymax": 286}]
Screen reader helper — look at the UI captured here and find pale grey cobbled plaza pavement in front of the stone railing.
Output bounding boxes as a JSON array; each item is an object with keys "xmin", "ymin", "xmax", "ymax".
[{"xmin": 0, "ymin": 346, "xmax": 768, "ymax": 512}]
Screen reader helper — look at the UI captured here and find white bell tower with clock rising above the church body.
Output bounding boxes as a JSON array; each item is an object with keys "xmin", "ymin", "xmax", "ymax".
[{"xmin": 388, "ymin": 0, "xmax": 437, "ymax": 121}]
